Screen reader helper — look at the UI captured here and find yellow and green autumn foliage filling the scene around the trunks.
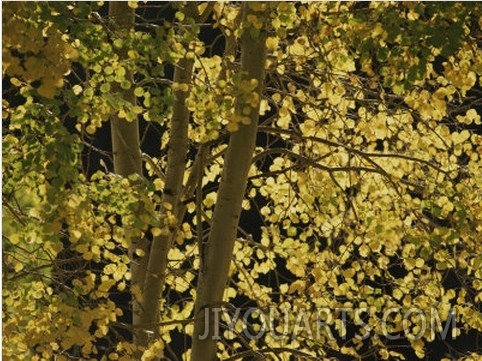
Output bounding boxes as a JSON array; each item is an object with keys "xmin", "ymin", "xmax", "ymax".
[{"xmin": 2, "ymin": 2, "xmax": 482, "ymax": 360}]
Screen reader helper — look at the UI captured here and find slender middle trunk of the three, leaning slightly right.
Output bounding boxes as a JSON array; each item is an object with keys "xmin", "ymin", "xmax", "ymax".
[{"xmin": 137, "ymin": 2, "xmax": 213, "ymax": 347}]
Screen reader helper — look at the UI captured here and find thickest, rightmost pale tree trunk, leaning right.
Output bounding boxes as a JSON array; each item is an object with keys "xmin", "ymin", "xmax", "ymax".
[{"xmin": 191, "ymin": 3, "xmax": 266, "ymax": 361}]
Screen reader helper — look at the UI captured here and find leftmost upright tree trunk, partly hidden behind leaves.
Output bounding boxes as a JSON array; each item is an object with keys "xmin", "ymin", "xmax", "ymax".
[{"xmin": 109, "ymin": 1, "xmax": 147, "ymax": 348}]
